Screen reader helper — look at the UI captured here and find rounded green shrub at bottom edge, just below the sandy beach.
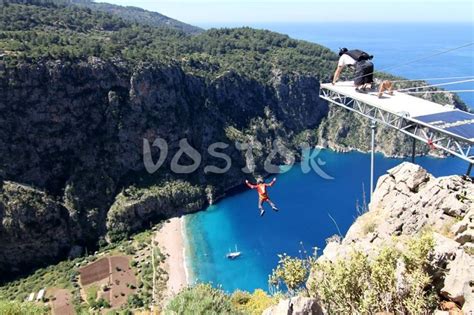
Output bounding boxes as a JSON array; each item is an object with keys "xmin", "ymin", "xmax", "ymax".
[{"xmin": 165, "ymin": 284, "xmax": 239, "ymax": 314}]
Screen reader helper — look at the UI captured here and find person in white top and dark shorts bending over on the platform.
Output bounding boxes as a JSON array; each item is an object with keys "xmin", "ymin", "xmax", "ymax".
[{"xmin": 332, "ymin": 48, "xmax": 374, "ymax": 92}]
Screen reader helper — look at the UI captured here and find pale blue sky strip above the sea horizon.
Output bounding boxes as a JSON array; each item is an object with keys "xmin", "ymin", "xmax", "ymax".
[{"xmin": 98, "ymin": 0, "xmax": 474, "ymax": 25}]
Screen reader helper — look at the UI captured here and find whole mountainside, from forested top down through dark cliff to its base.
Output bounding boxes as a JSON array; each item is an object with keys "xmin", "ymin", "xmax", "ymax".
[{"xmin": 0, "ymin": 0, "xmax": 466, "ymax": 275}]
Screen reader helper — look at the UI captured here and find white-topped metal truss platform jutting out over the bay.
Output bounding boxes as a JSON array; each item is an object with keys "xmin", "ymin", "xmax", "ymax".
[{"xmin": 320, "ymin": 82, "xmax": 474, "ymax": 191}]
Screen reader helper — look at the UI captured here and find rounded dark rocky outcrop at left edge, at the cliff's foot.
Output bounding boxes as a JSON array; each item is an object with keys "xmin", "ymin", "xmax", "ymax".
[{"xmin": 0, "ymin": 181, "xmax": 72, "ymax": 280}]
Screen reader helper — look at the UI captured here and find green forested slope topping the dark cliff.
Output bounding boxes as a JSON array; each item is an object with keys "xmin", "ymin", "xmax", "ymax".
[{"xmin": 0, "ymin": 0, "xmax": 335, "ymax": 80}]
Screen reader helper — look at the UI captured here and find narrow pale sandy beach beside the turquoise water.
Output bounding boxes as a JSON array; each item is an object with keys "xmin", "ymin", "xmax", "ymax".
[{"xmin": 156, "ymin": 217, "xmax": 188, "ymax": 298}]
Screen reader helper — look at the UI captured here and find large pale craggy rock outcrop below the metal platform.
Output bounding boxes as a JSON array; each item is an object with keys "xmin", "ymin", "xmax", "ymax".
[{"xmin": 319, "ymin": 163, "xmax": 474, "ymax": 312}]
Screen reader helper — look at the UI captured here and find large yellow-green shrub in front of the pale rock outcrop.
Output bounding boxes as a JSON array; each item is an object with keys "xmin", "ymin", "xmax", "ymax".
[{"xmin": 309, "ymin": 233, "xmax": 436, "ymax": 314}]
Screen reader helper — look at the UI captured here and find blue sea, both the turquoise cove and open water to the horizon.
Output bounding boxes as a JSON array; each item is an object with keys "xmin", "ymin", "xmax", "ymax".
[{"xmin": 185, "ymin": 23, "xmax": 474, "ymax": 291}]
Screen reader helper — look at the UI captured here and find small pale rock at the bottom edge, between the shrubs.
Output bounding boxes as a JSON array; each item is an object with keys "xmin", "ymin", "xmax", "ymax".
[{"xmin": 263, "ymin": 296, "xmax": 323, "ymax": 315}]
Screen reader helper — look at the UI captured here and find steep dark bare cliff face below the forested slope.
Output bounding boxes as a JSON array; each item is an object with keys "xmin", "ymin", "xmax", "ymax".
[{"xmin": 0, "ymin": 58, "xmax": 328, "ymax": 276}]
